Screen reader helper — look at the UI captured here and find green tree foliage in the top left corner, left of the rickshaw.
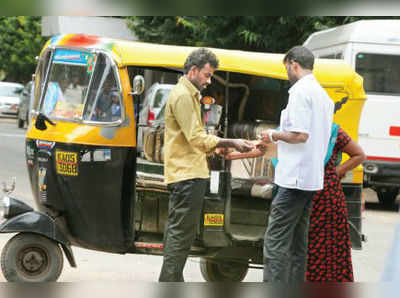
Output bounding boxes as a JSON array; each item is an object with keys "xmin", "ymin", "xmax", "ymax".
[{"xmin": 0, "ymin": 16, "xmax": 46, "ymax": 83}]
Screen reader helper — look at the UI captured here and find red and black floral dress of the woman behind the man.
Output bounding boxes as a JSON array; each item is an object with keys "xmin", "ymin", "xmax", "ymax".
[{"xmin": 306, "ymin": 128, "xmax": 354, "ymax": 282}]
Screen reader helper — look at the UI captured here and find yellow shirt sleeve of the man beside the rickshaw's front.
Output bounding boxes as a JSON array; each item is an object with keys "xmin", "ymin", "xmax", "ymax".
[{"xmin": 173, "ymin": 94, "xmax": 219, "ymax": 153}]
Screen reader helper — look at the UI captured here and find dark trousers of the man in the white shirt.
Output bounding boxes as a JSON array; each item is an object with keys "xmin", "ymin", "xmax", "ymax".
[{"xmin": 264, "ymin": 187, "xmax": 315, "ymax": 283}]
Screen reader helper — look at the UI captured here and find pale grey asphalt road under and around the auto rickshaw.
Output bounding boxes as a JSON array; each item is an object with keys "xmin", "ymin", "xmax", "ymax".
[{"xmin": 0, "ymin": 118, "xmax": 399, "ymax": 282}]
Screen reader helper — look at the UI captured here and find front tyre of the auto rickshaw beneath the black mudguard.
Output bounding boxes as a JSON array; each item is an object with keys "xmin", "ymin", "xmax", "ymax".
[{"xmin": 1, "ymin": 233, "xmax": 64, "ymax": 282}]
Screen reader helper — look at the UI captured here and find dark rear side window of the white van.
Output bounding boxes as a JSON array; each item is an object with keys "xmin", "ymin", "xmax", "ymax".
[{"xmin": 356, "ymin": 53, "xmax": 400, "ymax": 94}]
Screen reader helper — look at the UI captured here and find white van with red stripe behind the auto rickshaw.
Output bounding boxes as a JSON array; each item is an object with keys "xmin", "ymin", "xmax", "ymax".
[{"xmin": 304, "ymin": 20, "xmax": 400, "ymax": 204}]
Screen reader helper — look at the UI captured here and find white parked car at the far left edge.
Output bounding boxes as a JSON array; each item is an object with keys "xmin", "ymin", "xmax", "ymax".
[{"xmin": 0, "ymin": 82, "xmax": 24, "ymax": 115}]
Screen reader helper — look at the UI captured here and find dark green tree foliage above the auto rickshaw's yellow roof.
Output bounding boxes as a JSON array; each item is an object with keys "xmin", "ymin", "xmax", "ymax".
[{"xmin": 128, "ymin": 16, "xmax": 400, "ymax": 53}]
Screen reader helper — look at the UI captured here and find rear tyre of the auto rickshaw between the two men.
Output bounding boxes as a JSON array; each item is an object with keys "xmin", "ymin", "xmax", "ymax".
[{"xmin": 200, "ymin": 258, "xmax": 249, "ymax": 282}]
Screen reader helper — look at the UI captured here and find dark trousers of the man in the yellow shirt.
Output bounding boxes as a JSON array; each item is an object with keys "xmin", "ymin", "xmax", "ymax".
[{"xmin": 159, "ymin": 179, "xmax": 207, "ymax": 282}]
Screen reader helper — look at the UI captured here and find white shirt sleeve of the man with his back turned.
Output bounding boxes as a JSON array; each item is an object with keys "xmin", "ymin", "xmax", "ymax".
[{"xmin": 285, "ymin": 91, "xmax": 312, "ymax": 134}]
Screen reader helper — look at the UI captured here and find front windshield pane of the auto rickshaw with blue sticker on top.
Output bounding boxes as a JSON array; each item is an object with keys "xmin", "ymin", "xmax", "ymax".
[{"xmin": 41, "ymin": 49, "xmax": 95, "ymax": 119}]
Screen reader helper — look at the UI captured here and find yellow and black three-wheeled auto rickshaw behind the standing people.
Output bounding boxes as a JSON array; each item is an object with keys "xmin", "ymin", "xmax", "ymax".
[{"xmin": 0, "ymin": 34, "xmax": 365, "ymax": 281}]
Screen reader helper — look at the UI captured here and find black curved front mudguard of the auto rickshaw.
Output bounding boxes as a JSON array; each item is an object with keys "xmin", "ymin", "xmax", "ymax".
[{"xmin": 0, "ymin": 211, "xmax": 77, "ymax": 268}]
